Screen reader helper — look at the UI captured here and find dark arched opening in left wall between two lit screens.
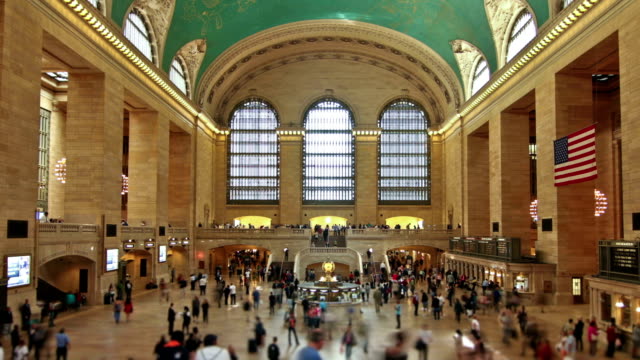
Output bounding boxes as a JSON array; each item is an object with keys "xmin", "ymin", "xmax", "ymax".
[{"xmin": 37, "ymin": 255, "xmax": 96, "ymax": 304}]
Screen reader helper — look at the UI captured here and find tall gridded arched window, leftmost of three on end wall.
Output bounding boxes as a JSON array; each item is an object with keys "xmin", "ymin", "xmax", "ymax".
[{"xmin": 227, "ymin": 98, "xmax": 280, "ymax": 204}]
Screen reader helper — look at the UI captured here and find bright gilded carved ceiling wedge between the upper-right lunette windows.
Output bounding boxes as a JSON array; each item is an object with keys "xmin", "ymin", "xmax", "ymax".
[{"xmin": 484, "ymin": 0, "xmax": 527, "ymax": 67}]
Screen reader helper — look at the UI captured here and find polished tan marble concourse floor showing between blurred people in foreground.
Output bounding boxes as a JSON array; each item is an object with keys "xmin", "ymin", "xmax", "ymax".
[{"xmin": 3, "ymin": 283, "xmax": 630, "ymax": 360}]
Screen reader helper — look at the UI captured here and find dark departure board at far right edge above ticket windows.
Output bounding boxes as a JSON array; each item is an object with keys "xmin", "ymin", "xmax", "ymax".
[{"xmin": 598, "ymin": 240, "xmax": 640, "ymax": 283}]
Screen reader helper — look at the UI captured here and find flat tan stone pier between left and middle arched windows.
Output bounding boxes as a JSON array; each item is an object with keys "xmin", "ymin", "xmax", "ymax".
[{"xmin": 273, "ymin": 129, "xmax": 307, "ymax": 224}]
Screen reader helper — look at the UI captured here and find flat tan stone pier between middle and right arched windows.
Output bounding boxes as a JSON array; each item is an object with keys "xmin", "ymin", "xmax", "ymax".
[{"xmin": 356, "ymin": 133, "xmax": 379, "ymax": 224}]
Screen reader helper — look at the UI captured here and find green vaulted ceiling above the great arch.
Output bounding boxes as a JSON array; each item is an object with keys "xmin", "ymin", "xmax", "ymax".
[{"xmin": 112, "ymin": 0, "xmax": 549, "ymax": 87}]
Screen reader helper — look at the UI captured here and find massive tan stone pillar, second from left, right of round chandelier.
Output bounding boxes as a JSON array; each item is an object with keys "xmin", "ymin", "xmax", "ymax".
[{"xmin": 64, "ymin": 73, "xmax": 124, "ymax": 224}]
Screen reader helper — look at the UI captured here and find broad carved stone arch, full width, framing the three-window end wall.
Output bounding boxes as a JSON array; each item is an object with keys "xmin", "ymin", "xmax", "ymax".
[{"xmin": 197, "ymin": 20, "xmax": 463, "ymax": 126}]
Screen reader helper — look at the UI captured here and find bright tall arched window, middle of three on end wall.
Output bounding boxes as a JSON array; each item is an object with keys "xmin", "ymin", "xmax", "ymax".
[{"xmin": 302, "ymin": 98, "xmax": 355, "ymax": 204}]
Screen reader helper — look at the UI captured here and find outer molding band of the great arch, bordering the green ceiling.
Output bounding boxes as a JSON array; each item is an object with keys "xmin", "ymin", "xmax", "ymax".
[{"xmin": 195, "ymin": 20, "xmax": 462, "ymax": 113}]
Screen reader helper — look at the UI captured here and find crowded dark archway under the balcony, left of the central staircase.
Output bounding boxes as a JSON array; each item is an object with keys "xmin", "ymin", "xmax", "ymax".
[{"xmin": 208, "ymin": 244, "xmax": 275, "ymax": 279}]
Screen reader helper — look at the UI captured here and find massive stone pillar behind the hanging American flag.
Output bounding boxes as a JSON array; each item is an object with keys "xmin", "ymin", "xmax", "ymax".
[{"xmin": 536, "ymin": 74, "xmax": 598, "ymax": 304}]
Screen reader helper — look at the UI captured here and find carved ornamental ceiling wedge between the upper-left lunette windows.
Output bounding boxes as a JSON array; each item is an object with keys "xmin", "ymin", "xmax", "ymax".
[{"xmin": 131, "ymin": 0, "xmax": 176, "ymax": 64}]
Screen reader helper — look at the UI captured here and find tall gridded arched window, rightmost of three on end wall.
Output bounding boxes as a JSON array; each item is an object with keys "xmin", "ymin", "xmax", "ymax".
[{"xmin": 378, "ymin": 99, "xmax": 430, "ymax": 204}]
